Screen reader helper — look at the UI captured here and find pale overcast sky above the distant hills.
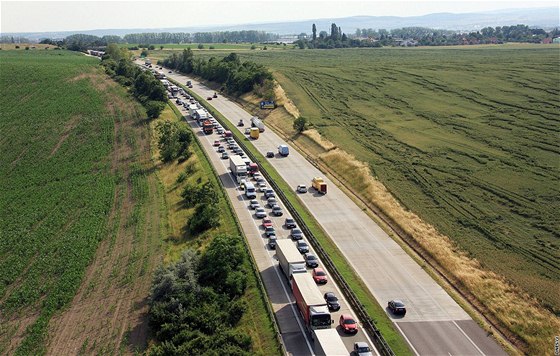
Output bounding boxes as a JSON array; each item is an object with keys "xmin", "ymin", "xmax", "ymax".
[{"xmin": 0, "ymin": 0, "xmax": 558, "ymax": 33}]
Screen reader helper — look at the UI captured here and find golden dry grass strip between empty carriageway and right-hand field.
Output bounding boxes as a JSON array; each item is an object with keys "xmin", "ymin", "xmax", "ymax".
[{"xmin": 320, "ymin": 149, "xmax": 560, "ymax": 355}]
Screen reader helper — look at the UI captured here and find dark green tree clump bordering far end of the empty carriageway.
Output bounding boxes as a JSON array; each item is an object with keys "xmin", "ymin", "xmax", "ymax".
[{"xmin": 158, "ymin": 48, "xmax": 274, "ymax": 99}]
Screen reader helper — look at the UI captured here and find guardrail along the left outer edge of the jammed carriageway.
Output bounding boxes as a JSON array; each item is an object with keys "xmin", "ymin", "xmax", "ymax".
[{"xmin": 169, "ymin": 102, "xmax": 288, "ymax": 355}]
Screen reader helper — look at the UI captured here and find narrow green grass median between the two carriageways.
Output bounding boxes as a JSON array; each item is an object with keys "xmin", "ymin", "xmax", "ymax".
[{"xmin": 177, "ymin": 82, "xmax": 410, "ymax": 355}]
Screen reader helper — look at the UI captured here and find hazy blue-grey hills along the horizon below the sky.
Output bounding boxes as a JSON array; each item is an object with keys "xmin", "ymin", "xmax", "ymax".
[{"xmin": 2, "ymin": 7, "xmax": 560, "ymax": 40}]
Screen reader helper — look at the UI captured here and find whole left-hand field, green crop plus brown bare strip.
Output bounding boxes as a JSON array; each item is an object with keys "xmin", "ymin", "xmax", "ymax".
[{"xmin": 0, "ymin": 50, "xmax": 164, "ymax": 354}]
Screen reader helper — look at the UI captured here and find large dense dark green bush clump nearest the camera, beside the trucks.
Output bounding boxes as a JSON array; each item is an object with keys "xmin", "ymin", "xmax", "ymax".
[{"xmin": 147, "ymin": 235, "xmax": 252, "ymax": 355}]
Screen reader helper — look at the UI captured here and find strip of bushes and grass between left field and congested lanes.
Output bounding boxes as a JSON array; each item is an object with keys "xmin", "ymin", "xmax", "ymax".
[{"xmin": 147, "ymin": 105, "xmax": 280, "ymax": 355}]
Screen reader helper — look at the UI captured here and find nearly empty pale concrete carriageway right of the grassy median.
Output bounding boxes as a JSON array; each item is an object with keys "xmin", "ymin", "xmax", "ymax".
[{"xmin": 147, "ymin": 62, "xmax": 505, "ymax": 355}]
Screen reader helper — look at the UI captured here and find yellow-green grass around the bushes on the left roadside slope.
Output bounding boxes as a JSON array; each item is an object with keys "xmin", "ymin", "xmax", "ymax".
[{"xmin": 150, "ymin": 105, "xmax": 279, "ymax": 355}]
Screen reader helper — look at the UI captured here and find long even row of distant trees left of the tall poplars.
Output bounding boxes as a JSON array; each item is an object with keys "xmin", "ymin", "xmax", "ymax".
[{"xmin": 122, "ymin": 30, "xmax": 279, "ymax": 44}]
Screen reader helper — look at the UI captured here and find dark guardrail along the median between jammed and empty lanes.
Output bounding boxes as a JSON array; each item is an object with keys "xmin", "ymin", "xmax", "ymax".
[{"xmin": 168, "ymin": 76, "xmax": 395, "ymax": 356}]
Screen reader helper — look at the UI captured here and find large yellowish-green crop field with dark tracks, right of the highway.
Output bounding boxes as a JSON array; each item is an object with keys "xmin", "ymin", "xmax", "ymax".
[{"xmin": 219, "ymin": 46, "xmax": 560, "ymax": 312}]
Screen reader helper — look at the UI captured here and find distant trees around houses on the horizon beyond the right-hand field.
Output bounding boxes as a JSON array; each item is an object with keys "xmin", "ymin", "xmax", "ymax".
[{"xmin": 355, "ymin": 25, "xmax": 560, "ymax": 46}]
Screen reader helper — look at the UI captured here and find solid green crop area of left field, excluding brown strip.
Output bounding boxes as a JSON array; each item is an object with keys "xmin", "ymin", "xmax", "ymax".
[{"xmin": 0, "ymin": 51, "xmax": 121, "ymax": 353}]
